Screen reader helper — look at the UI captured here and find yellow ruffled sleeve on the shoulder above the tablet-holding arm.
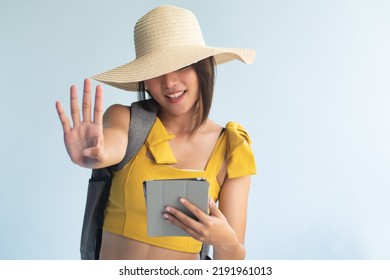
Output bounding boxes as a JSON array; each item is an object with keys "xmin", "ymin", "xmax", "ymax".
[{"xmin": 226, "ymin": 122, "xmax": 256, "ymax": 178}]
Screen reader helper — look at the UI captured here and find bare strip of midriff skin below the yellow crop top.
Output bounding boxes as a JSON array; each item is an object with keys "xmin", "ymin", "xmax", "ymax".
[{"xmin": 100, "ymin": 231, "xmax": 199, "ymax": 260}]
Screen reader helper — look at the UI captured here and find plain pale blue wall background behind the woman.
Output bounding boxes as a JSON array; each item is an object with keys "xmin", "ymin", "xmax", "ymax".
[{"xmin": 0, "ymin": 0, "xmax": 390, "ymax": 259}]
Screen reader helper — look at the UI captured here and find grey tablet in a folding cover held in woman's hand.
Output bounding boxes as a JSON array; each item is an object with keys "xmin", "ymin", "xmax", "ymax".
[{"xmin": 144, "ymin": 178, "xmax": 209, "ymax": 236}]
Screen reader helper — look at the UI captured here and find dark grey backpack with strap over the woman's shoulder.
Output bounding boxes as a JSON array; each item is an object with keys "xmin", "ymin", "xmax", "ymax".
[{"xmin": 80, "ymin": 99, "xmax": 210, "ymax": 260}]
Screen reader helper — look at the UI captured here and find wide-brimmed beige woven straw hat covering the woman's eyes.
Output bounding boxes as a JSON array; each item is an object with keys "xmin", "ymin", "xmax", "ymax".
[{"xmin": 92, "ymin": 6, "xmax": 255, "ymax": 91}]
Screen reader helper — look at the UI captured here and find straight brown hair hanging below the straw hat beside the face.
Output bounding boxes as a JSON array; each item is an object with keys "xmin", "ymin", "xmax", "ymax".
[{"xmin": 138, "ymin": 56, "xmax": 215, "ymax": 132}]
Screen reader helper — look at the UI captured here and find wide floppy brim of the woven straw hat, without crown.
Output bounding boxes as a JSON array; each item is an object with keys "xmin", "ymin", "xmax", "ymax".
[{"xmin": 92, "ymin": 46, "xmax": 256, "ymax": 91}]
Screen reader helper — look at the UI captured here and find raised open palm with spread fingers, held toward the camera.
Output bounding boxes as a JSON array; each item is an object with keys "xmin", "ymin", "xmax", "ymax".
[{"xmin": 56, "ymin": 79, "xmax": 106, "ymax": 168}]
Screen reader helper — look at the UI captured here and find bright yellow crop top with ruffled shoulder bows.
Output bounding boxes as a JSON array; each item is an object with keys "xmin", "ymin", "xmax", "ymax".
[{"xmin": 103, "ymin": 118, "xmax": 256, "ymax": 253}]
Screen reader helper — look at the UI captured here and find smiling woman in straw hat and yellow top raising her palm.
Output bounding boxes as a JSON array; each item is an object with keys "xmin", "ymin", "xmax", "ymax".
[{"xmin": 56, "ymin": 6, "xmax": 256, "ymax": 259}]
